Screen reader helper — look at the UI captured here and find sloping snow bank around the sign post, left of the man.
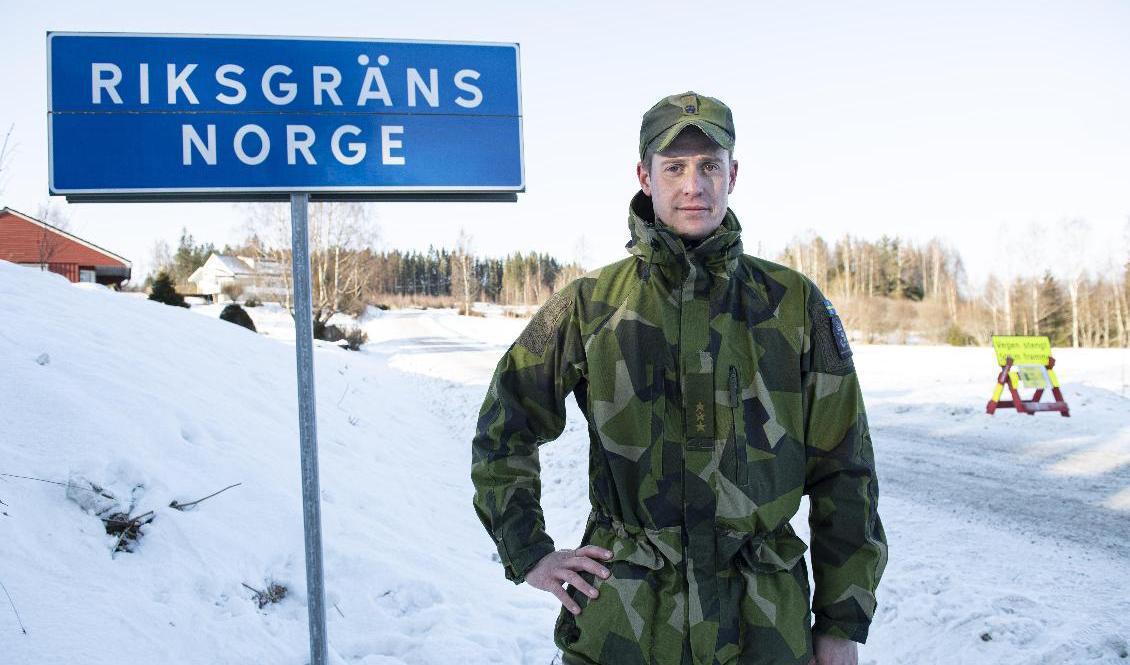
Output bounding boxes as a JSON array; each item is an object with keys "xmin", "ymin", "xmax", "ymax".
[{"xmin": 0, "ymin": 261, "xmax": 553, "ymax": 665}]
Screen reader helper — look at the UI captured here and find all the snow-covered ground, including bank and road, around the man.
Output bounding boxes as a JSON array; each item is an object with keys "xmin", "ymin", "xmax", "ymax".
[{"xmin": 0, "ymin": 261, "xmax": 1130, "ymax": 665}]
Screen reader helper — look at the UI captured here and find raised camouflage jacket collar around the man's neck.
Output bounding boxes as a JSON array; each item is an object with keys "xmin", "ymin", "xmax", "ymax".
[{"xmin": 626, "ymin": 190, "xmax": 741, "ymax": 274}]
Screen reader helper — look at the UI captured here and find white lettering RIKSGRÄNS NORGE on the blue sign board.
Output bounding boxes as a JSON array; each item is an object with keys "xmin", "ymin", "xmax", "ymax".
[{"xmin": 83, "ymin": 54, "xmax": 483, "ymax": 166}]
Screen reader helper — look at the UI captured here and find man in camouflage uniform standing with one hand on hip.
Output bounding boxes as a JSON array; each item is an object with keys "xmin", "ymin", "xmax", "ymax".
[{"xmin": 471, "ymin": 93, "xmax": 886, "ymax": 665}]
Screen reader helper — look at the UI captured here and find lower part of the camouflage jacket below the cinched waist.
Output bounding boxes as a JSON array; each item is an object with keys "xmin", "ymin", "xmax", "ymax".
[{"xmin": 554, "ymin": 511, "xmax": 812, "ymax": 665}]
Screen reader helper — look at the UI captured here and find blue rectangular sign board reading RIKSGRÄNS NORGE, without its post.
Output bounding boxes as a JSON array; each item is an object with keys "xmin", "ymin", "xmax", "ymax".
[{"xmin": 47, "ymin": 33, "xmax": 524, "ymax": 198}]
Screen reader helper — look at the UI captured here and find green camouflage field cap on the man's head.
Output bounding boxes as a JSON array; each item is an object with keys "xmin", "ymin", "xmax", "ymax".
[{"xmin": 640, "ymin": 90, "xmax": 736, "ymax": 159}]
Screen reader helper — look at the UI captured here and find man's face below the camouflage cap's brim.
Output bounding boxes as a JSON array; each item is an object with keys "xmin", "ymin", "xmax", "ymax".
[{"xmin": 636, "ymin": 127, "xmax": 738, "ymax": 240}]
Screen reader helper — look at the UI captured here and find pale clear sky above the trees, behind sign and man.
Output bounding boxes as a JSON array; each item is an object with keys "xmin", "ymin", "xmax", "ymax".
[{"xmin": 0, "ymin": 0, "xmax": 1130, "ymax": 288}]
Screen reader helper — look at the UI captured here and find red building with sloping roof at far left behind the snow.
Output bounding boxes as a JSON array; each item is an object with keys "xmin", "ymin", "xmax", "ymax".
[{"xmin": 0, "ymin": 208, "xmax": 131, "ymax": 287}]
